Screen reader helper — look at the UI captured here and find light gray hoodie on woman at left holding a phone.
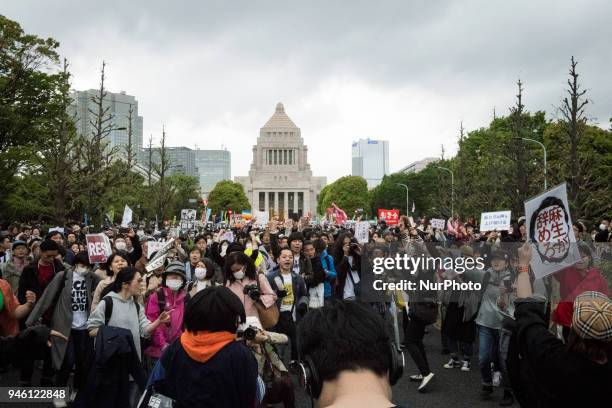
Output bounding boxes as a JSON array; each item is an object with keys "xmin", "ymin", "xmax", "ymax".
[{"xmin": 87, "ymin": 291, "xmax": 151, "ymax": 358}]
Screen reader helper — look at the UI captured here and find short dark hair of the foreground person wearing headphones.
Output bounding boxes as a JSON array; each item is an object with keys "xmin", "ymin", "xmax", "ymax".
[{"xmin": 297, "ymin": 300, "xmax": 391, "ymax": 383}]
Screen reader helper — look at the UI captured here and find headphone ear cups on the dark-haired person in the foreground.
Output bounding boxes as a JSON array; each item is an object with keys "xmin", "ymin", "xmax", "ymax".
[{"xmin": 298, "ymin": 340, "xmax": 406, "ymax": 398}]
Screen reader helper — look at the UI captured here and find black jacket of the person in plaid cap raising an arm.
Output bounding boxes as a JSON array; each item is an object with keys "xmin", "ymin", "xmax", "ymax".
[{"xmin": 508, "ymin": 299, "xmax": 612, "ymax": 408}]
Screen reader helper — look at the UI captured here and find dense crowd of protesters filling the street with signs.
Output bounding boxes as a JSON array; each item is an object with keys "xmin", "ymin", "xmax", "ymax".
[{"xmin": 0, "ymin": 216, "xmax": 612, "ymax": 407}]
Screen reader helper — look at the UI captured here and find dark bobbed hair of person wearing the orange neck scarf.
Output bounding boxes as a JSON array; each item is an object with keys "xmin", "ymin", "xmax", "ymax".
[{"xmin": 183, "ymin": 286, "xmax": 246, "ymax": 333}]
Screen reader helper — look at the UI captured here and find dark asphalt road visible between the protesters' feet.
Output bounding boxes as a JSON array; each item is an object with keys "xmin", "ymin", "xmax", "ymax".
[{"xmin": 0, "ymin": 326, "xmax": 518, "ymax": 408}]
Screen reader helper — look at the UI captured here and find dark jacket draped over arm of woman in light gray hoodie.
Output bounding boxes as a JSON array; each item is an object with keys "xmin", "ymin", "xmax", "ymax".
[{"xmin": 74, "ymin": 326, "xmax": 145, "ymax": 408}]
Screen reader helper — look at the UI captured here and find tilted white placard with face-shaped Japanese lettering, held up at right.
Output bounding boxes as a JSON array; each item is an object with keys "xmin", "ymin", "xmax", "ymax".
[{"xmin": 525, "ymin": 183, "xmax": 580, "ymax": 278}]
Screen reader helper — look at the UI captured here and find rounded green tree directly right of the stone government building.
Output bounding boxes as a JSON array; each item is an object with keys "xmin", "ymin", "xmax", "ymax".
[{"xmin": 318, "ymin": 176, "xmax": 370, "ymax": 218}]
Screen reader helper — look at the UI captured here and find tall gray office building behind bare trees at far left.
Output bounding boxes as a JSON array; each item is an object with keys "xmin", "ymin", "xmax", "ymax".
[{"xmin": 68, "ymin": 89, "xmax": 142, "ymax": 157}]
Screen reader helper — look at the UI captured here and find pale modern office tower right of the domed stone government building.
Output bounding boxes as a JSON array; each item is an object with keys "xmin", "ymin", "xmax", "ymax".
[{"xmin": 351, "ymin": 139, "xmax": 389, "ymax": 188}]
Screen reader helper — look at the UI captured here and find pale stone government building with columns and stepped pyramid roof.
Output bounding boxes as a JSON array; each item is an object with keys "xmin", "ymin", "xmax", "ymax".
[{"xmin": 234, "ymin": 103, "xmax": 327, "ymax": 218}]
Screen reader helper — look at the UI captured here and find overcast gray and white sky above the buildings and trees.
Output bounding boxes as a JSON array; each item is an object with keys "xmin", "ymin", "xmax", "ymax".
[{"xmin": 5, "ymin": 0, "xmax": 612, "ymax": 181}]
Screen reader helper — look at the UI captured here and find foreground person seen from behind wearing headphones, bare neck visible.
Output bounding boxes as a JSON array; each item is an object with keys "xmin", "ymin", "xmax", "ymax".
[{"xmin": 298, "ymin": 300, "xmax": 404, "ymax": 408}]
